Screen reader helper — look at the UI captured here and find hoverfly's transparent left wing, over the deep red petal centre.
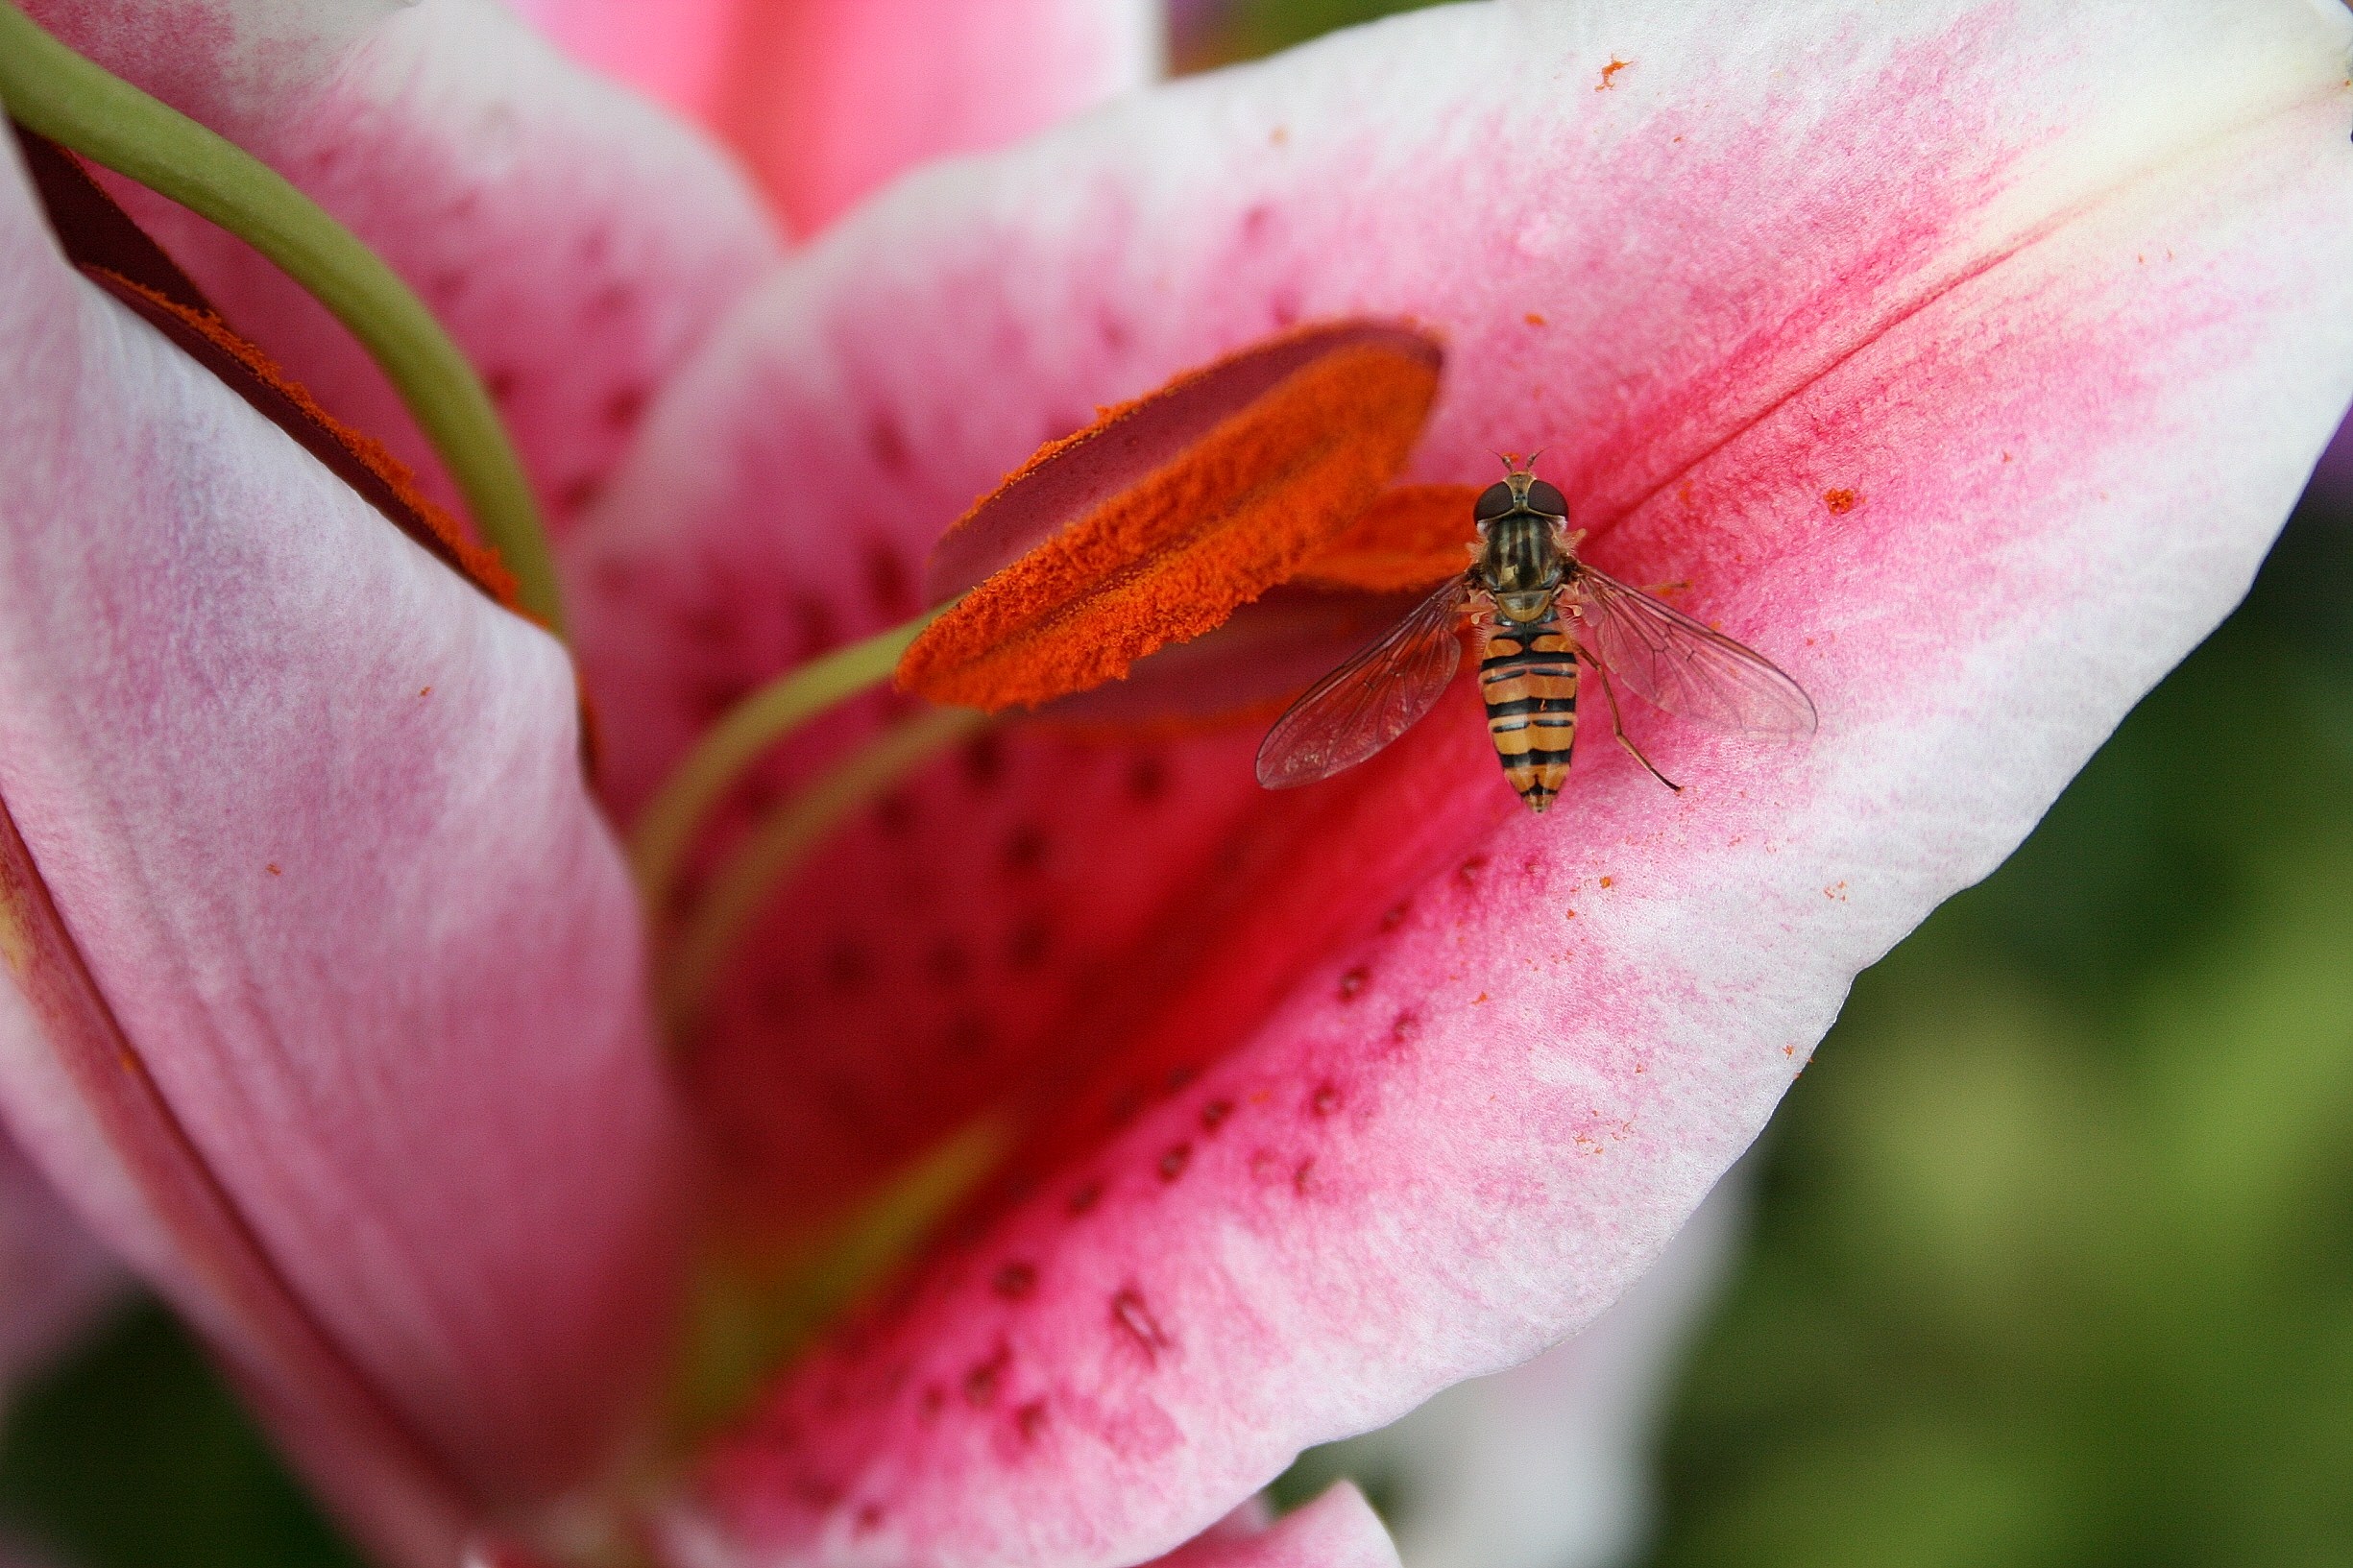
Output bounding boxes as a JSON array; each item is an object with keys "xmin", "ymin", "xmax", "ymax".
[{"xmin": 1259, "ymin": 578, "xmax": 1468, "ymax": 790}]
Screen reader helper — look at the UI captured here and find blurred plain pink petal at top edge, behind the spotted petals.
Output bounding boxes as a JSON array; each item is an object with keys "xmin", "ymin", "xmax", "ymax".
[{"xmin": 522, "ymin": 0, "xmax": 1162, "ymax": 235}]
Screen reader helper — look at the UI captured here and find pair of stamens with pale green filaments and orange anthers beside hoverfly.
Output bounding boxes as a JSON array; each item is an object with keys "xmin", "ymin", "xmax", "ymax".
[{"xmin": 631, "ymin": 322, "xmax": 1468, "ymax": 1034}]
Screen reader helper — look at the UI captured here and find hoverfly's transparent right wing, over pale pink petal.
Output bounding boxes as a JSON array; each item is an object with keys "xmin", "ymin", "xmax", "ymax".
[{"xmin": 1577, "ymin": 565, "xmax": 1816, "ymax": 736}]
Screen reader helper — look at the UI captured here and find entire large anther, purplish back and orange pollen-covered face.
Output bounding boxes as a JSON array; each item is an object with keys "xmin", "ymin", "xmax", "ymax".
[{"xmin": 899, "ymin": 322, "xmax": 1440, "ymax": 712}]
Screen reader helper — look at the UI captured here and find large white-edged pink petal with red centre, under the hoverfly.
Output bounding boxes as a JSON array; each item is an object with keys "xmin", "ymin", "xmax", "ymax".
[{"xmin": 555, "ymin": 0, "xmax": 2353, "ymax": 1563}]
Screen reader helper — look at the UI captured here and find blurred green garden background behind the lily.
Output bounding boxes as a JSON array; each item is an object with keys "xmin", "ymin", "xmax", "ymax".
[{"xmin": 0, "ymin": 0, "xmax": 2353, "ymax": 1568}]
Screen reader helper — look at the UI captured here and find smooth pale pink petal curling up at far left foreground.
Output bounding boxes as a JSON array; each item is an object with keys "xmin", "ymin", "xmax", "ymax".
[{"xmin": 0, "ymin": 134, "xmax": 680, "ymax": 1563}]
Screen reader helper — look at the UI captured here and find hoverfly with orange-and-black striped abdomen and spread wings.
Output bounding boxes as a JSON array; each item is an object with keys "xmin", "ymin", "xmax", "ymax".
[{"xmin": 1259, "ymin": 456, "xmax": 1814, "ymax": 811}]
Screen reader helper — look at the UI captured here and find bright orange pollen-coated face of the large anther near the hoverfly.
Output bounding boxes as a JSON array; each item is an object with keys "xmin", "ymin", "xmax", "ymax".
[{"xmin": 896, "ymin": 343, "xmax": 1459, "ymax": 712}]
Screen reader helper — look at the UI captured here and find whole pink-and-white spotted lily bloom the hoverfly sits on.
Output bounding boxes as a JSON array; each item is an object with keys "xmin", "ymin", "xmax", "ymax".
[{"xmin": 0, "ymin": 0, "xmax": 2353, "ymax": 1568}]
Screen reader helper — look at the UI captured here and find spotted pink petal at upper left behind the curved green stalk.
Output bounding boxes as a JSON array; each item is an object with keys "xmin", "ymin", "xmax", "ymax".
[{"xmin": 28, "ymin": 0, "xmax": 777, "ymax": 529}]
